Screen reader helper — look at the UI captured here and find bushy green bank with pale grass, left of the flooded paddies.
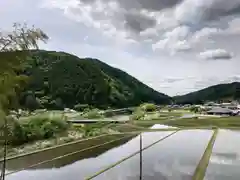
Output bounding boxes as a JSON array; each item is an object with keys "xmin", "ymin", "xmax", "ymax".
[{"xmin": 0, "ymin": 111, "xmax": 119, "ymax": 157}]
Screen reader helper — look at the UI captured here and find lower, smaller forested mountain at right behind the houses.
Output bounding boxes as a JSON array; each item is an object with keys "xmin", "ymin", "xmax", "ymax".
[{"xmin": 174, "ymin": 82, "xmax": 240, "ymax": 104}]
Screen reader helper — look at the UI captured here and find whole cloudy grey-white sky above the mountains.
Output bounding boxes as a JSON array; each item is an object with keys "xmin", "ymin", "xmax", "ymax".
[{"xmin": 0, "ymin": 0, "xmax": 240, "ymax": 95}]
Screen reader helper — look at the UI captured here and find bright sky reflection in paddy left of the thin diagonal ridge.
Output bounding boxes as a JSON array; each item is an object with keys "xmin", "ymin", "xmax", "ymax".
[{"xmin": 6, "ymin": 128, "xmax": 172, "ymax": 180}]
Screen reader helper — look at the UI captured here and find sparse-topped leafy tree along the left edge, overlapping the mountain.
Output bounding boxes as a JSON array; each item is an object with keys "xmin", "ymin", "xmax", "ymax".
[{"xmin": 0, "ymin": 23, "xmax": 48, "ymax": 179}]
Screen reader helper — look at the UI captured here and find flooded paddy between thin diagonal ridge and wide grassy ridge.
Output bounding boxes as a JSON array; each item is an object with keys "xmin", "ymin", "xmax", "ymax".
[{"xmin": 95, "ymin": 130, "xmax": 212, "ymax": 180}]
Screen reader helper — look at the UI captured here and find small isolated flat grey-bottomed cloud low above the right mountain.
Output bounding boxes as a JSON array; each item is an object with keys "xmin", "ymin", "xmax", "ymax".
[{"xmin": 199, "ymin": 49, "xmax": 233, "ymax": 59}]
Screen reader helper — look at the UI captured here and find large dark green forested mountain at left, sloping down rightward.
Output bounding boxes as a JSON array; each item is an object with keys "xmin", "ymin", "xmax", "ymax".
[{"xmin": 20, "ymin": 50, "xmax": 171, "ymax": 109}]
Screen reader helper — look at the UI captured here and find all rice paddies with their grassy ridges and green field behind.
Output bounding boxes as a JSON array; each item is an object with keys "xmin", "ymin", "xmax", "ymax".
[{"xmin": 3, "ymin": 111, "xmax": 240, "ymax": 180}]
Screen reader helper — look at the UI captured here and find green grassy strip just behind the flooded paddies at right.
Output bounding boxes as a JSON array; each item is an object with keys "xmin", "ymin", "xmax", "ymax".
[{"xmin": 130, "ymin": 105, "xmax": 240, "ymax": 129}]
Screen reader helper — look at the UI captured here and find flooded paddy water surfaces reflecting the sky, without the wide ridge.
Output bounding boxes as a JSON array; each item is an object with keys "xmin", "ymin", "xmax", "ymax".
[{"xmin": 6, "ymin": 125, "xmax": 240, "ymax": 180}]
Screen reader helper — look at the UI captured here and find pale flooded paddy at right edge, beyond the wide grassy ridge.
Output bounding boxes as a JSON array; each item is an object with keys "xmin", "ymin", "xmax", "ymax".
[{"xmin": 205, "ymin": 130, "xmax": 240, "ymax": 180}]
